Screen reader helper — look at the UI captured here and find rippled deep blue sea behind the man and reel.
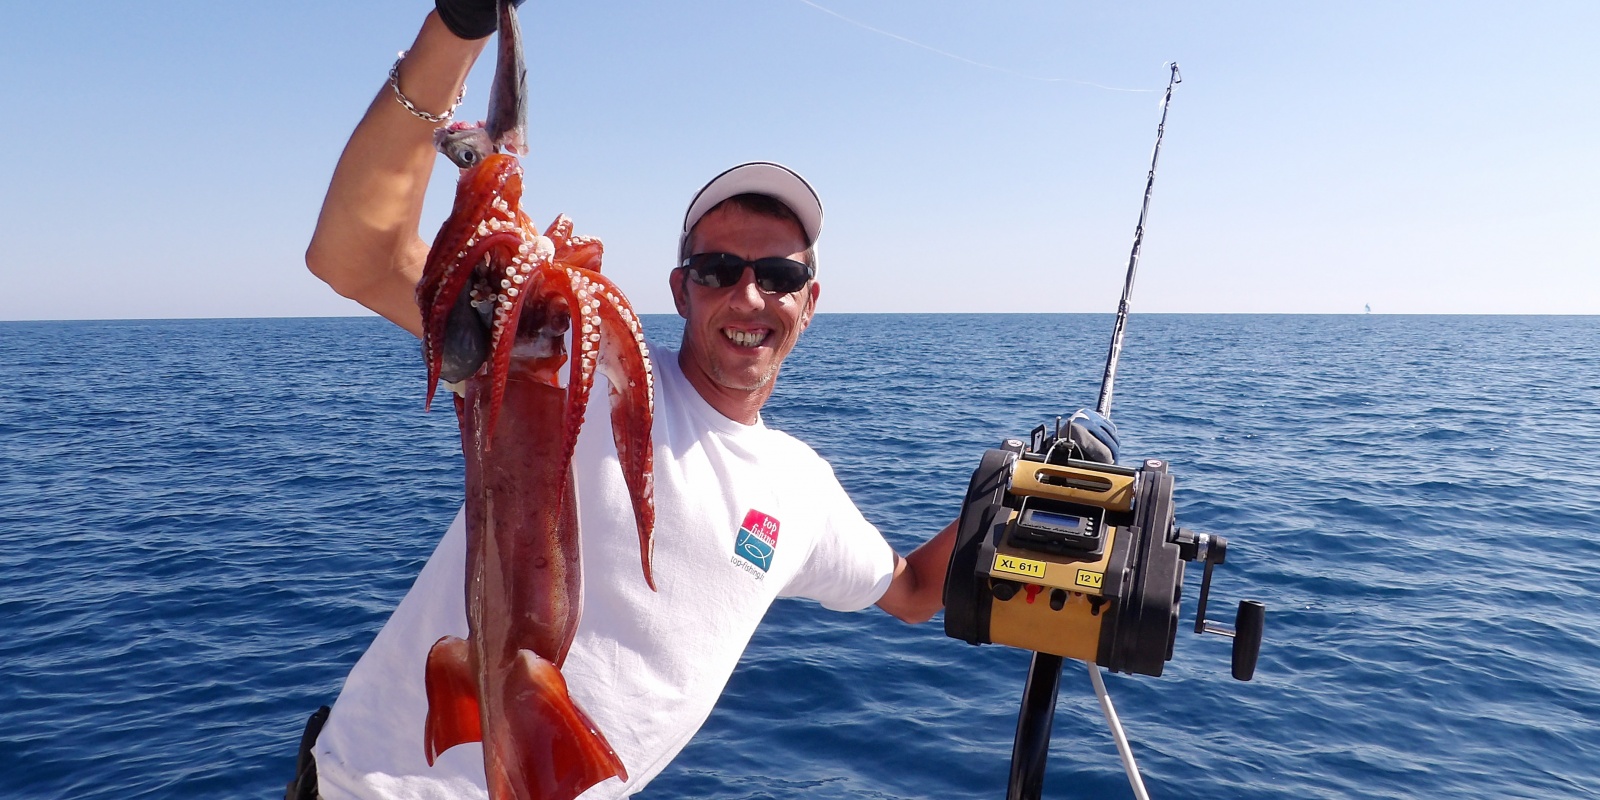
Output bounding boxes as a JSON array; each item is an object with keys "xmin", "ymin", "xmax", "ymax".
[{"xmin": 0, "ymin": 314, "xmax": 1600, "ymax": 800}]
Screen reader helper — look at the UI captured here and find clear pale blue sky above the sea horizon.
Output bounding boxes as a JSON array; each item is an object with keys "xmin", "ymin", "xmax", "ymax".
[{"xmin": 0, "ymin": 0, "xmax": 1600, "ymax": 320}]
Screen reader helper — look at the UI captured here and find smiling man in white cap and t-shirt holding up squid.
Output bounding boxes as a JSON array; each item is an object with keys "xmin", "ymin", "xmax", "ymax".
[{"xmin": 291, "ymin": 2, "xmax": 955, "ymax": 800}]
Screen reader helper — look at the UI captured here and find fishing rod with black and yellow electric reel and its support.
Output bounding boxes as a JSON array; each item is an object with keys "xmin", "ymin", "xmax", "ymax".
[{"xmin": 944, "ymin": 62, "xmax": 1266, "ymax": 800}]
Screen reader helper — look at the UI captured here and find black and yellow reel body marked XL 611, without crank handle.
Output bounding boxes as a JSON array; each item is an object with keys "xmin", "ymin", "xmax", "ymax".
[{"xmin": 944, "ymin": 440, "xmax": 1184, "ymax": 675}]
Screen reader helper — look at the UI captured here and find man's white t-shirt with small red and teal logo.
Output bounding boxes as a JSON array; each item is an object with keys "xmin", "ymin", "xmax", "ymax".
[{"xmin": 314, "ymin": 347, "xmax": 894, "ymax": 800}]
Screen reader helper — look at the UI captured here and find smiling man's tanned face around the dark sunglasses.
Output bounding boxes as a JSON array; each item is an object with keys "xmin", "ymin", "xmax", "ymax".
[{"xmin": 670, "ymin": 205, "xmax": 821, "ymax": 422}]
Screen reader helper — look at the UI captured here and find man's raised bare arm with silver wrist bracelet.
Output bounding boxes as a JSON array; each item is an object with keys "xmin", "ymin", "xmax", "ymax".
[{"xmin": 306, "ymin": 13, "xmax": 486, "ymax": 336}]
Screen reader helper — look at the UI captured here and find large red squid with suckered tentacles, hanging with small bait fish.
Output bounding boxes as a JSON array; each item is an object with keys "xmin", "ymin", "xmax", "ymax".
[{"xmin": 416, "ymin": 0, "xmax": 654, "ymax": 800}]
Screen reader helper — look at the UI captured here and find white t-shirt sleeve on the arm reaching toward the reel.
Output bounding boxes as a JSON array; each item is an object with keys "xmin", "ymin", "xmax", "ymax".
[{"xmin": 779, "ymin": 466, "xmax": 894, "ymax": 611}]
